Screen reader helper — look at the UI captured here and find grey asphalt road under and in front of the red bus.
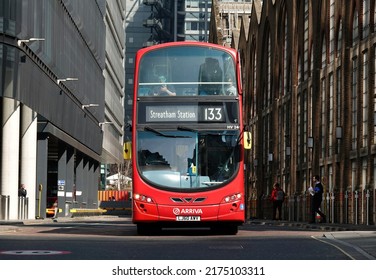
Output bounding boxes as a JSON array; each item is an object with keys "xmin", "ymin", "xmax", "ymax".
[{"xmin": 0, "ymin": 216, "xmax": 376, "ymax": 260}]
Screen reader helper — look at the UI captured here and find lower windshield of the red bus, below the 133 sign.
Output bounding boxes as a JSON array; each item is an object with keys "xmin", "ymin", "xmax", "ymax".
[{"xmin": 137, "ymin": 128, "xmax": 239, "ymax": 190}]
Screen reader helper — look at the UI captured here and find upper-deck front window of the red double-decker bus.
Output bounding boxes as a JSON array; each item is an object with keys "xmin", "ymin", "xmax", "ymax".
[{"xmin": 137, "ymin": 46, "xmax": 238, "ymax": 96}]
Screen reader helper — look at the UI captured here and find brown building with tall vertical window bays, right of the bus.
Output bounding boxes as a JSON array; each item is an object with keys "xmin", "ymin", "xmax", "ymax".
[{"xmin": 211, "ymin": 0, "xmax": 376, "ymax": 224}]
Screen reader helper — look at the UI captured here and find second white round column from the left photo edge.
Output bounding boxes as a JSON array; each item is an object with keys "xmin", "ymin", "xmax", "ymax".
[{"xmin": 20, "ymin": 105, "xmax": 37, "ymax": 219}]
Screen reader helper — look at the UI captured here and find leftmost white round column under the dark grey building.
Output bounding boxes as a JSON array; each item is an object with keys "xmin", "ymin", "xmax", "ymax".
[{"xmin": 0, "ymin": 98, "xmax": 20, "ymax": 220}]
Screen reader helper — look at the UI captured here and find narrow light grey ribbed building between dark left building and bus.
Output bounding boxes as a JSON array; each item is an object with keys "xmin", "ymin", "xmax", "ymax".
[{"xmin": 101, "ymin": 0, "xmax": 126, "ymax": 186}]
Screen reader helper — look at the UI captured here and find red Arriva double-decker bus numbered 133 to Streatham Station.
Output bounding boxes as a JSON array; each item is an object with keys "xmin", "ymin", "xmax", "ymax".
[{"xmin": 132, "ymin": 42, "xmax": 250, "ymax": 234}]
